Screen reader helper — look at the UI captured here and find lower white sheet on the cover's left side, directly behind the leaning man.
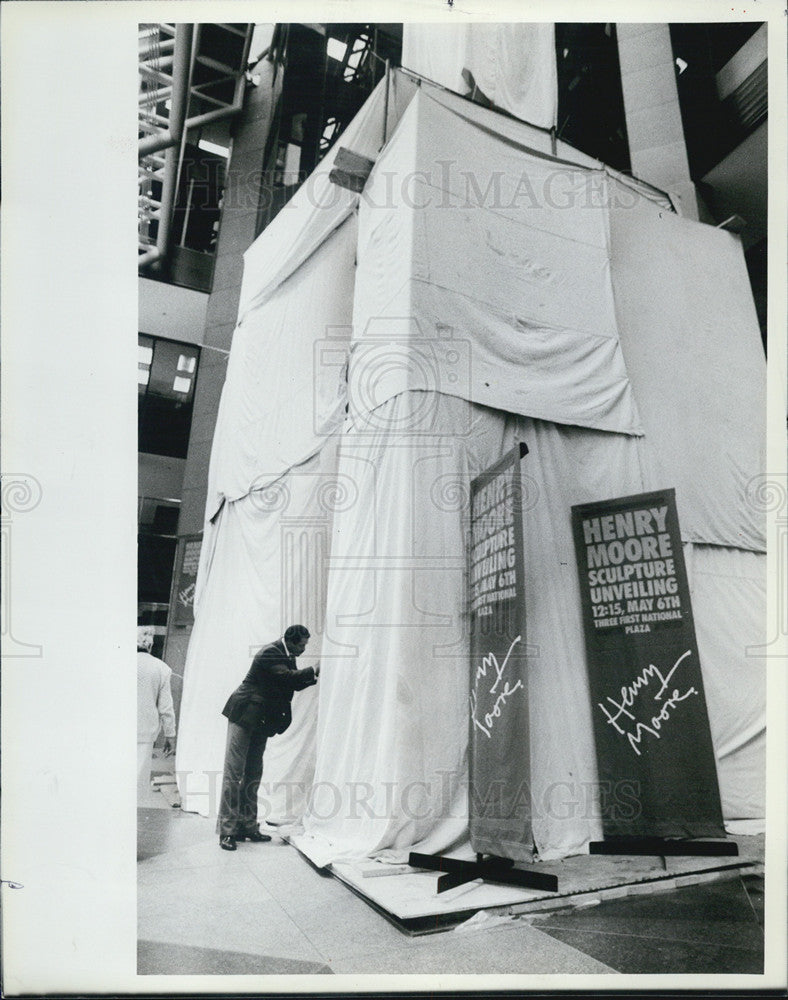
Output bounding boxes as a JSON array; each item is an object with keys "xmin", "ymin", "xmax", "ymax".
[{"xmin": 176, "ymin": 446, "xmax": 348, "ymax": 821}]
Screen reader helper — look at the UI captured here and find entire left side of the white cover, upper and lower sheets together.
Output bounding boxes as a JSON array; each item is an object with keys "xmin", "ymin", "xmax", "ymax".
[{"xmin": 177, "ymin": 223, "xmax": 356, "ymax": 819}]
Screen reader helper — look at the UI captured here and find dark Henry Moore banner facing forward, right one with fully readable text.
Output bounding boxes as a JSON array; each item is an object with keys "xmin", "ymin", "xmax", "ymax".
[{"xmin": 572, "ymin": 489, "xmax": 725, "ymax": 837}]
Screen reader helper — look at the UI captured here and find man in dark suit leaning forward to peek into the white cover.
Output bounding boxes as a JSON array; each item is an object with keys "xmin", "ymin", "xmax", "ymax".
[{"xmin": 216, "ymin": 625, "xmax": 320, "ymax": 851}]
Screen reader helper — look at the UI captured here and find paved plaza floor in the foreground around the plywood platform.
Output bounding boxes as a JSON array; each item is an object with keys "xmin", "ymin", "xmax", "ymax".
[{"xmin": 138, "ymin": 764, "xmax": 763, "ymax": 987}]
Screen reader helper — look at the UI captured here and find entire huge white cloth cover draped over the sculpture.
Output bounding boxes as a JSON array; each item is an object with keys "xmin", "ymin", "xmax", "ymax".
[{"xmin": 178, "ymin": 68, "xmax": 764, "ymax": 863}]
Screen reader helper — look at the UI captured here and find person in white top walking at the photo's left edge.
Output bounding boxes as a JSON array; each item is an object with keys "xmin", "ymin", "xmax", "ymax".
[{"xmin": 137, "ymin": 625, "xmax": 175, "ymax": 800}]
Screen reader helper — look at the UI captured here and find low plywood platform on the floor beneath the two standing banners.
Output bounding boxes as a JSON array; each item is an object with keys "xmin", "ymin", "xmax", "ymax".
[{"xmin": 292, "ymin": 836, "xmax": 764, "ymax": 934}]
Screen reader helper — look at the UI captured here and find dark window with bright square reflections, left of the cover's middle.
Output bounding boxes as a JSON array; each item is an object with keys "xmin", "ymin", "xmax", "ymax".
[{"xmin": 137, "ymin": 334, "xmax": 200, "ymax": 458}]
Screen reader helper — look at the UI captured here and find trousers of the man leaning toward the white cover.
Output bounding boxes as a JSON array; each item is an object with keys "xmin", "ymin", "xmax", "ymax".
[{"xmin": 216, "ymin": 722, "xmax": 267, "ymax": 837}]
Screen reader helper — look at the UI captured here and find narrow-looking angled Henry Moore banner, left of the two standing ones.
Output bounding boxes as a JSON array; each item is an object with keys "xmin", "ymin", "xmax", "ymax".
[{"xmin": 468, "ymin": 443, "xmax": 533, "ymax": 861}]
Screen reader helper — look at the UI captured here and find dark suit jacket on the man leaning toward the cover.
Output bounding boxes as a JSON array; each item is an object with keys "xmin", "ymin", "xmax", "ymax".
[{"xmin": 222, "ymin": 639, "xmax": 317, "ymax": 736}]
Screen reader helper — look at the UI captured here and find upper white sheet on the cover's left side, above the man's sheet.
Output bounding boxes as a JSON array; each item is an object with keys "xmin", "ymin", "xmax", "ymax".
[{"xmin": 207, "ymin": 215, "xmax": 356, "ymax": 519}]
